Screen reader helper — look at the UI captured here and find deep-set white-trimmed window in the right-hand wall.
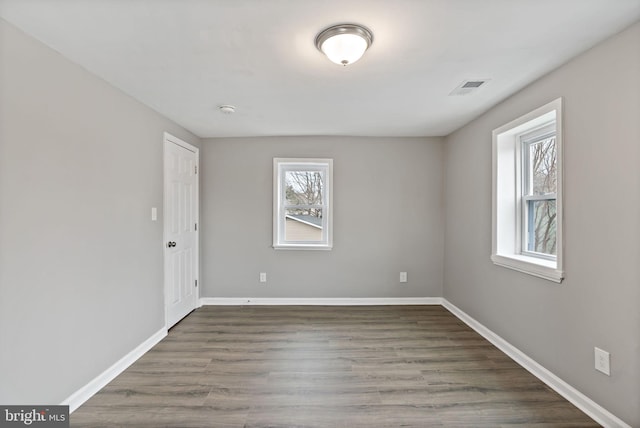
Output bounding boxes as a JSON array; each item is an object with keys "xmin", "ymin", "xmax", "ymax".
[{"xmin": 491, "ymin": 98, "xmax": 564, "ymax": 282}]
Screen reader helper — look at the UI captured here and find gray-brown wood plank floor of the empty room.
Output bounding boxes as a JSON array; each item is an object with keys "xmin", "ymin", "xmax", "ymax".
[{"xmin": 71, "ymin": 306, "xmax": 599, "ymax": 428}]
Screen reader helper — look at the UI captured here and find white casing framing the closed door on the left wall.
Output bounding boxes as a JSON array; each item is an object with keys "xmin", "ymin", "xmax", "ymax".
[{"xmin": 162, "ymin": 132, "xmax": 201, "ymax": 330}]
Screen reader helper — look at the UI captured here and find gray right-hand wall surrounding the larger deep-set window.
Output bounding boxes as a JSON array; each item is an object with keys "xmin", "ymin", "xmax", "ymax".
[{"xmin": 444, "ymin": 20, "xmax": 640, "ymax": 426}]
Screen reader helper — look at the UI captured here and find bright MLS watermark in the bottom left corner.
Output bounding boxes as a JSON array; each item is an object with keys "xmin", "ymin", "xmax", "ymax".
[{"xmin": 0, "ymin": 406, "xmax": 69, "ymax": 428}]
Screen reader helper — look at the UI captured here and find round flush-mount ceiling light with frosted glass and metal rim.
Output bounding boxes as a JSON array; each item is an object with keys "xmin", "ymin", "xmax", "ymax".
[{"xmin": 316, "ymin": 24, "xmax": 373, "ymax": 65}]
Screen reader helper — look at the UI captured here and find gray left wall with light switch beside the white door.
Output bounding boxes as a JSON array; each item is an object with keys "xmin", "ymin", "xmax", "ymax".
[{"xmin": 0, "ymin": 20, "xmax": 199, "ymax": 404}]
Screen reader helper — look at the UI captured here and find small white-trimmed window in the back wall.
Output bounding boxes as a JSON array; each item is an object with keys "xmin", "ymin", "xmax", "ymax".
[{"xmin": 273, "ymin": 158, "xmax": 333, "ymax": 250}]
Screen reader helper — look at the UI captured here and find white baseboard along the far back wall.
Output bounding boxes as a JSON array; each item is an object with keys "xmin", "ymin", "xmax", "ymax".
[{"xmin": 200, "ymin": 297, "xmax": 442, "ymax": 306}]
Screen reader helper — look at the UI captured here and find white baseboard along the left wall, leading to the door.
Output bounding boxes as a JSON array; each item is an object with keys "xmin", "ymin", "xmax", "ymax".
[{"xmin": 61, "ymin": 328, "xmax": 167, "ymax": 412}]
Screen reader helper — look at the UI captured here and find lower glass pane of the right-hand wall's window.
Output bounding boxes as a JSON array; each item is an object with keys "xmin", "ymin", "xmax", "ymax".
[{"xmin": 527, "ymin": 199, "xmax": 556, "ymax": 255}]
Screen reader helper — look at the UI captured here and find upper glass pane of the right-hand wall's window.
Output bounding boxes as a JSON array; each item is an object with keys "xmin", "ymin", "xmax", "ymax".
[{"xmin": 529, "ymin": 136, "xmax": 557, "ymax": 195}]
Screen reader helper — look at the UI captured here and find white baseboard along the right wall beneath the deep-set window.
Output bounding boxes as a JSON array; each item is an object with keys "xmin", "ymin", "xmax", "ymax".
[{"xmin": 442, "ymin": 298, "xmax": 631, "ymax": 428}]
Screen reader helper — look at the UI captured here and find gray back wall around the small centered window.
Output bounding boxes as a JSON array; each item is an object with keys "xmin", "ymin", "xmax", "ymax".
[{"xmin": 200, "ymin": 137, "xmax": 444, "ymax": 297}]
